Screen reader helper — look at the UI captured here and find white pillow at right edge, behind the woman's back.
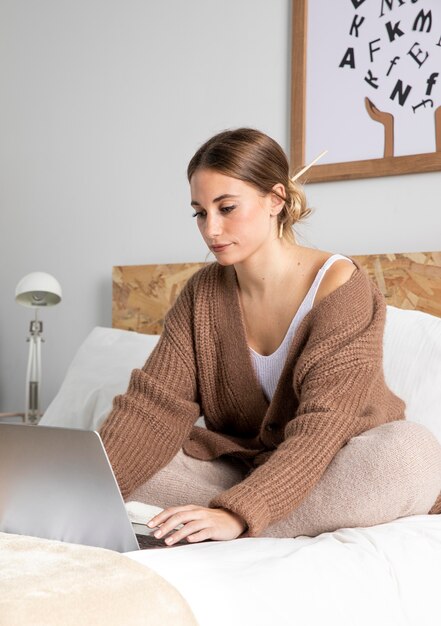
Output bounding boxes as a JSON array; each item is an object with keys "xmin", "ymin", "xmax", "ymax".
[{"xmin": 383, "ymin": 305, "xmax": 441, "ymax": 443}]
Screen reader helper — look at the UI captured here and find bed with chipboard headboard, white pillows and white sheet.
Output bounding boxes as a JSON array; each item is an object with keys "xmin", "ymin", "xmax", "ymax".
[{"xmin": 13, "ymin": 252, "xmax": 441, "ymax": 626}]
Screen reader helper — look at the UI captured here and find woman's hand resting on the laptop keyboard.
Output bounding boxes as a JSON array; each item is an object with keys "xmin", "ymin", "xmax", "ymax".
[{"xmin": 147, "ymin": 504, "xmax": 247, "ymax": 545}]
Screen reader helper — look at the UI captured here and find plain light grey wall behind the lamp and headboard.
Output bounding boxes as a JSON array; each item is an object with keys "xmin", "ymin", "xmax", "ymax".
[{"xmin": 0, "ymin": 0, "xmax": 441, "ymax": 411}]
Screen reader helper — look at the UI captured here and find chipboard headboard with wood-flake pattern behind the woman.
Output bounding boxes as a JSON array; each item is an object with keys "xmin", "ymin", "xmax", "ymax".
[{"xmin": 112, "ymin": 252, "xmax": 441, "ymax": 335}]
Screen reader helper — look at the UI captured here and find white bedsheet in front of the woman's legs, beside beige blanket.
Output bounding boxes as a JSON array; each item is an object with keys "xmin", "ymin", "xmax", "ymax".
[{"xmin": 127, "ymin": 515, "xmax": 441, "ymax": 626}]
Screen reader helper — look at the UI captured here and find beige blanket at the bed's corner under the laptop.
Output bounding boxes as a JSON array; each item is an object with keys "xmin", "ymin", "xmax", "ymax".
[{"xmin": 0, "ymin": 533, "xmax": 197, "ymax": 626}]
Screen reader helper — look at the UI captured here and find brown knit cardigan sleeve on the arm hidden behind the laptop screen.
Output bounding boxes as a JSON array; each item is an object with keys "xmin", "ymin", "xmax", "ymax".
[{"xmin": 100, "ymin": 279, "xmax": 200, "ymax": 498}]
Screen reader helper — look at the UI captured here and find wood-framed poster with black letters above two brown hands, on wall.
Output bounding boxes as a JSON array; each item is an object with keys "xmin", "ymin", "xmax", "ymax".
[{"xmin": 290, "ymin": 0, "xmax": 441, "ymax": 182}]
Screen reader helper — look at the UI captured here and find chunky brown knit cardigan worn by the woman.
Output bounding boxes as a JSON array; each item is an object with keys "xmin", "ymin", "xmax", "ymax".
[{"xmin": 100, "ymin": 259, "xmax": 405, "ymax": 537}]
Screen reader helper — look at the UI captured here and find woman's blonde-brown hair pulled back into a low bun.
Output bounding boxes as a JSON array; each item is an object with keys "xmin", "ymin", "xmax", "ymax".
[{"xmin": 187, "ymin": 128, "xmax": 312, "ymax": 243}]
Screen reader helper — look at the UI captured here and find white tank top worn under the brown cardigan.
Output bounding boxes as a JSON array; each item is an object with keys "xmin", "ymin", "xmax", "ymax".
[{"xmin": 250, "ymin": 254, "xmax": 352, "ymax": 402}]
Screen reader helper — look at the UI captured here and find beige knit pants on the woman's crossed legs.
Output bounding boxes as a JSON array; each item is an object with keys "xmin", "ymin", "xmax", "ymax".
[{"xmin": 128, "ymin": 420, "xmax": 441, "ymax": 537}]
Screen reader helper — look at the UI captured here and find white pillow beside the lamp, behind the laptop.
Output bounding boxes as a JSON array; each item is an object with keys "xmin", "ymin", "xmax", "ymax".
[{"xmin": 40, "ymin": 326, "xmax": 159, "ymax": 430}]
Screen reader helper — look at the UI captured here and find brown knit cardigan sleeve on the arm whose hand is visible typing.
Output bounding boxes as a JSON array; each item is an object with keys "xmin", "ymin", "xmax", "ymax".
[{"xmin": 210, "ymin": 276, "xmax": 385, "ymax": 537}]
